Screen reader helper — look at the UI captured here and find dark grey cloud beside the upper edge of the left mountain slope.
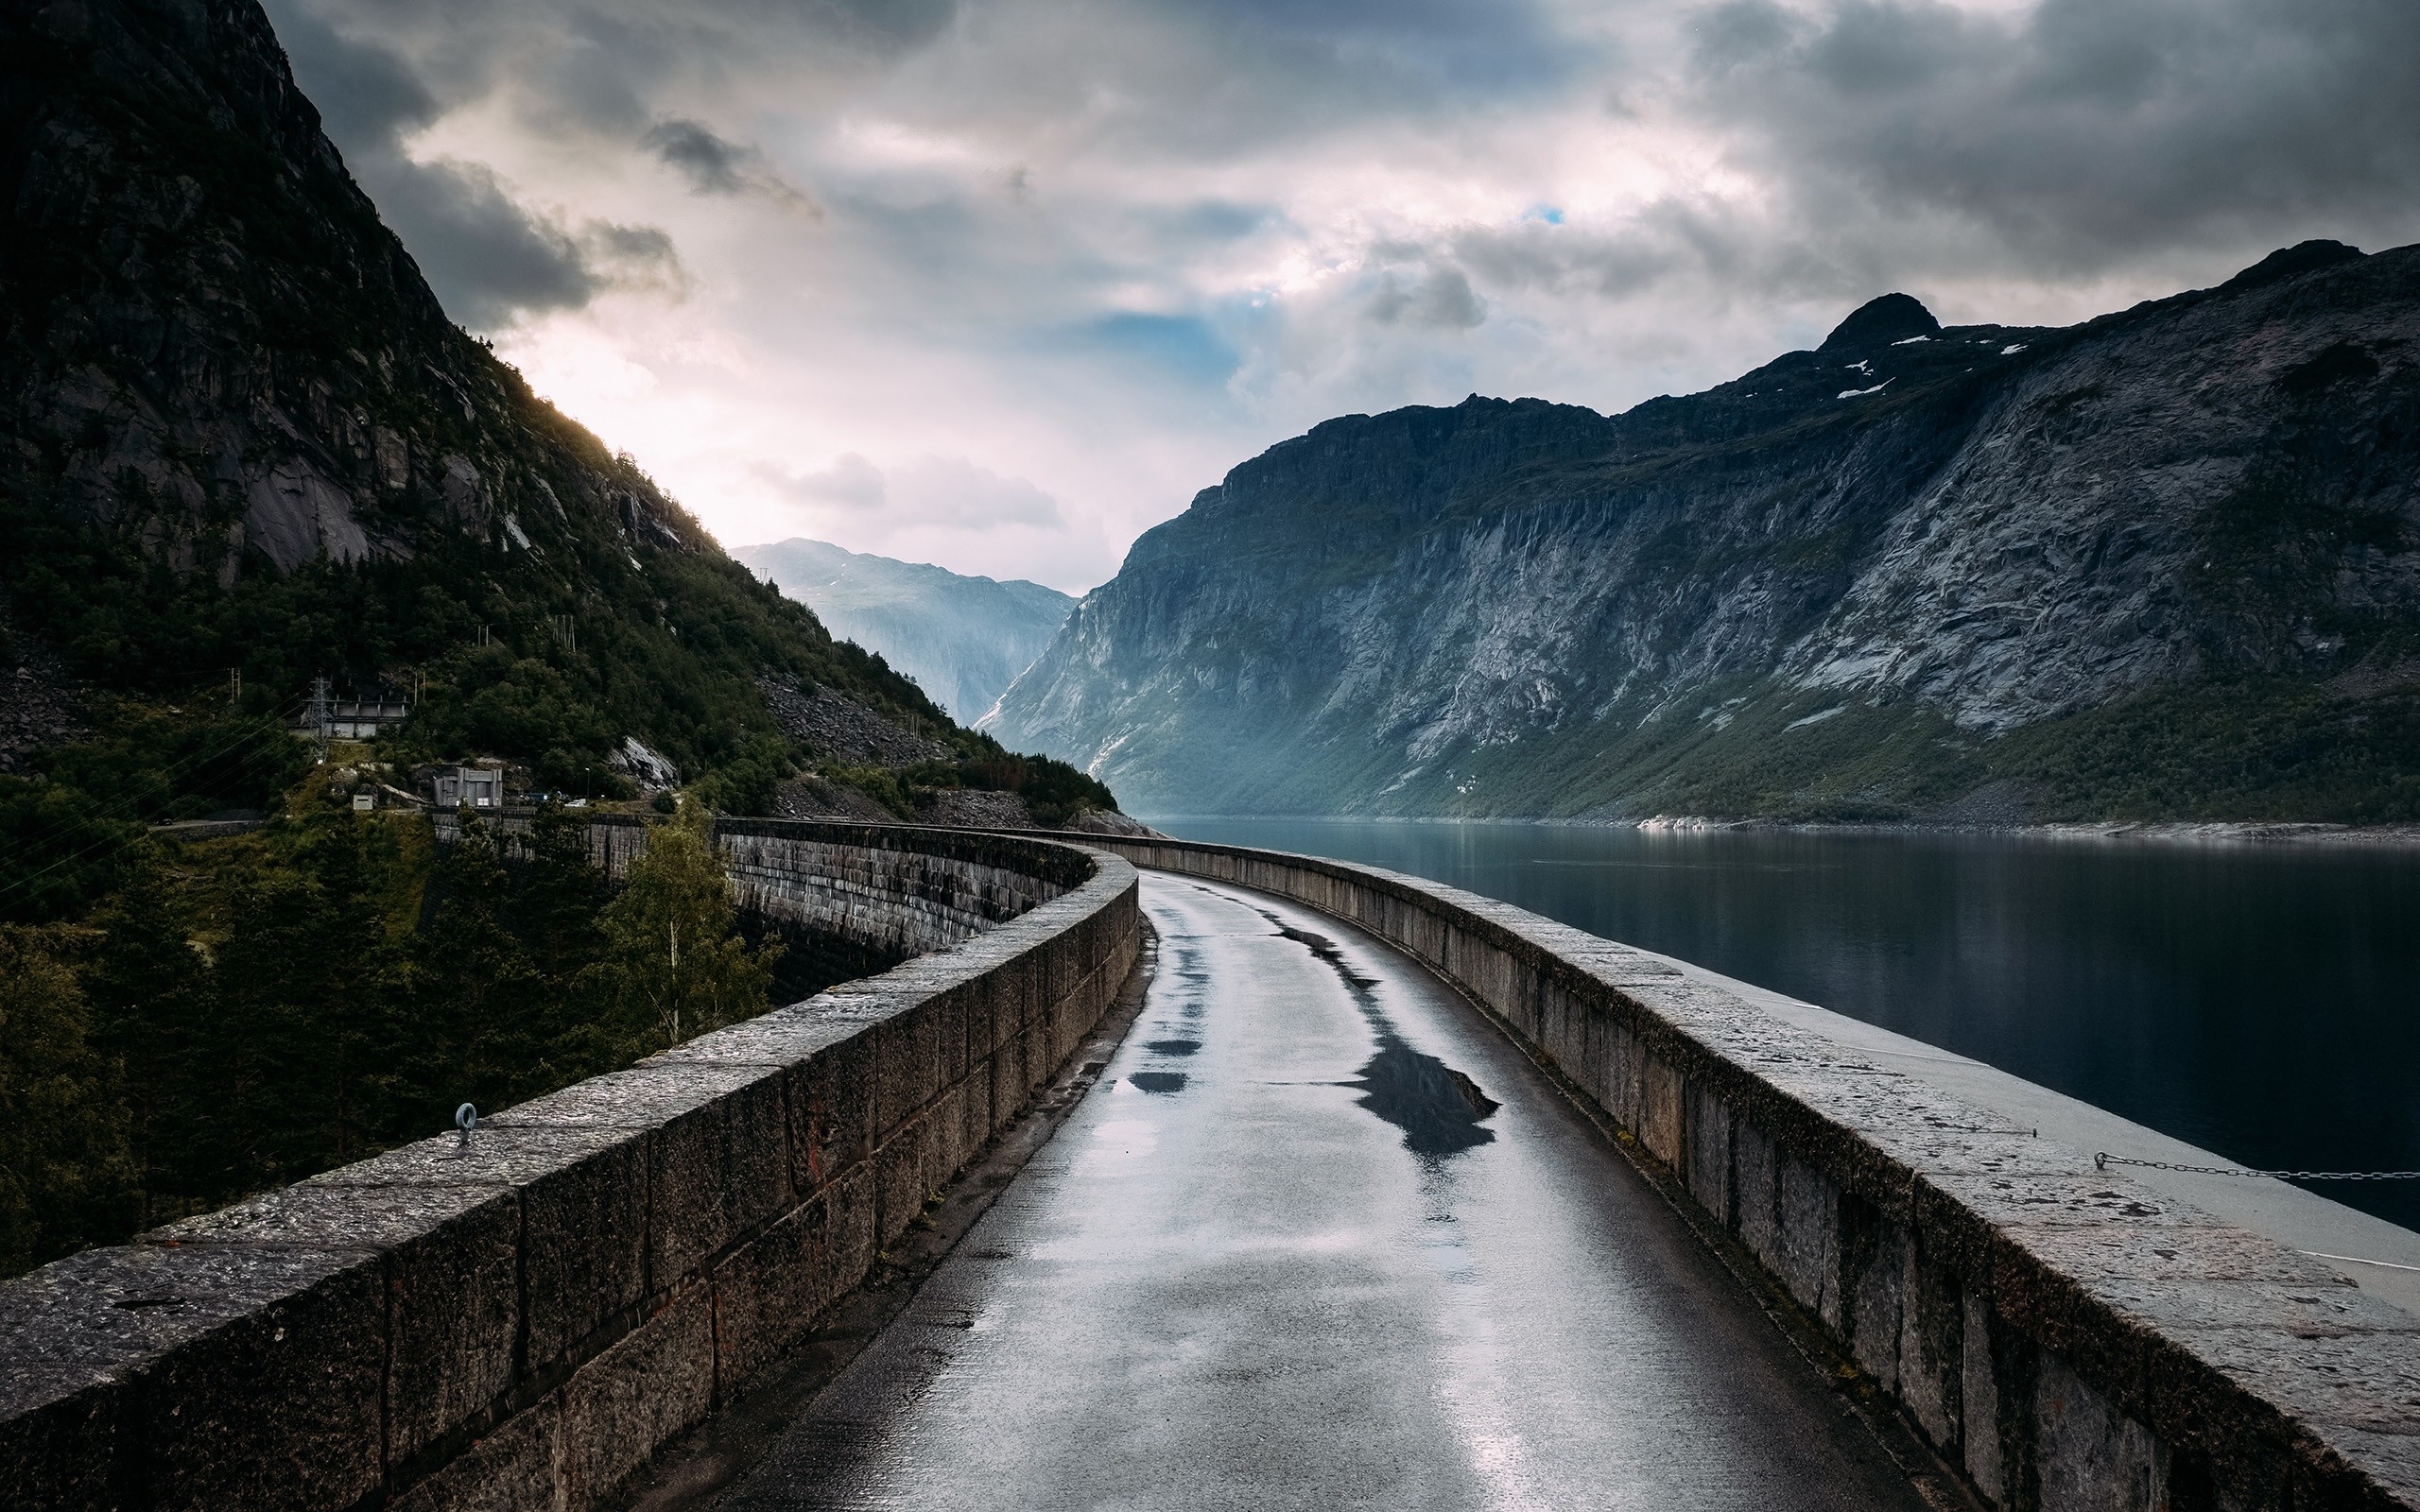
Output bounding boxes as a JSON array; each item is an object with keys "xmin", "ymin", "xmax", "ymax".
[{"xmin": 271, "ymin": 3, "xmax": 680, "ymax": 329}]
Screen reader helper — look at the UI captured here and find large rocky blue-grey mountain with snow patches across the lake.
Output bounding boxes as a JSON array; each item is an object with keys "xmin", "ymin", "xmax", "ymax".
[{"xmin": 993, "ymin": 242, "xmax": 2420, "ymax": 820}]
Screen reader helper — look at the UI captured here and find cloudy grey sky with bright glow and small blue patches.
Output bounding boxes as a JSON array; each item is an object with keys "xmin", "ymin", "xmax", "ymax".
[{"xmin": 268, "ymin": 0, "xmax": 2420, "ymax": 591}]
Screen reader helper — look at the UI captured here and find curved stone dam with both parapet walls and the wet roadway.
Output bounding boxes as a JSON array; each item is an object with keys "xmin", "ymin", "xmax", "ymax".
[{"xmin": 0, "ymin": 820, "xmax": 2420, "ymax": 1512}]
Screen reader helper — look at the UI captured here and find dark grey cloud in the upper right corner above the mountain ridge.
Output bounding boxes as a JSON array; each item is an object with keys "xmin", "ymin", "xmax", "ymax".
[{"xmin": 1689, "ymin": 0, "xmax": 2420, "ymax": 273}]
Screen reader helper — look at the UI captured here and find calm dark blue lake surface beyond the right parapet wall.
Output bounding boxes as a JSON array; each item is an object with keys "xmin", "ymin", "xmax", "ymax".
[{"xmin": 1152, "ymin": 817, "xmax": 2420, "ymax": 1228}]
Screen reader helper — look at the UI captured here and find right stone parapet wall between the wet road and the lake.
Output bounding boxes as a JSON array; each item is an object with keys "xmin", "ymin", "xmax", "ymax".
[{"xmin": 1092, "ymin": 837, "xmax": 2420, "ymax": 1512}]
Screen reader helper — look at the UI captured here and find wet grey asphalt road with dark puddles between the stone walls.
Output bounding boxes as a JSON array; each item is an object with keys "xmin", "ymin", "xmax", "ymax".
[{"xmin": 717, "ymin": 873, "xmax": 1922, "ymax": 1512}]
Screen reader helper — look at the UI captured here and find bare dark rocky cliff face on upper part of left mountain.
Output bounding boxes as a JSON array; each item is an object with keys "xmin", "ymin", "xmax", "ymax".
[{"xmin": 0, "ymin": 0, "xmax": 595, "ymax": 568}]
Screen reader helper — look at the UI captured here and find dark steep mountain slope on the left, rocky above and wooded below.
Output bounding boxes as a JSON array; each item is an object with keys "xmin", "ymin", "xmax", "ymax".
[{"xmin": 0, "ymin": 0, "xmax": 946, "ymax": 816}]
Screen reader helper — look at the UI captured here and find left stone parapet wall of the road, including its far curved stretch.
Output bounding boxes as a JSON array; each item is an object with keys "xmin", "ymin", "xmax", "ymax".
[{"xmin": 0, "ymin": 822, "xmax": 1142, "ymax": 1512}]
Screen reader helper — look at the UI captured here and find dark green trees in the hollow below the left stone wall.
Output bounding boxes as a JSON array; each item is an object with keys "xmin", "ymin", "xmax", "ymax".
[{"xmin": 0, "ymin": 782, "xmax": 779, "ymax": 1275}]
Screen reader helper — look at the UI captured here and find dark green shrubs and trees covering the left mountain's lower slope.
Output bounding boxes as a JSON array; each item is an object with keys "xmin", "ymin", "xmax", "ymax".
[{"xmin": 0, "ymin": 486, "xmax": 946, "ymax": 800}]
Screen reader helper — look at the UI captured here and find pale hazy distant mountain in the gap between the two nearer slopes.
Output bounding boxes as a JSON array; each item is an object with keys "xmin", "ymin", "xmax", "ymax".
[{"xmin": 731, "ymin": 540, "xmax": 1075, "ymax": 723}]
